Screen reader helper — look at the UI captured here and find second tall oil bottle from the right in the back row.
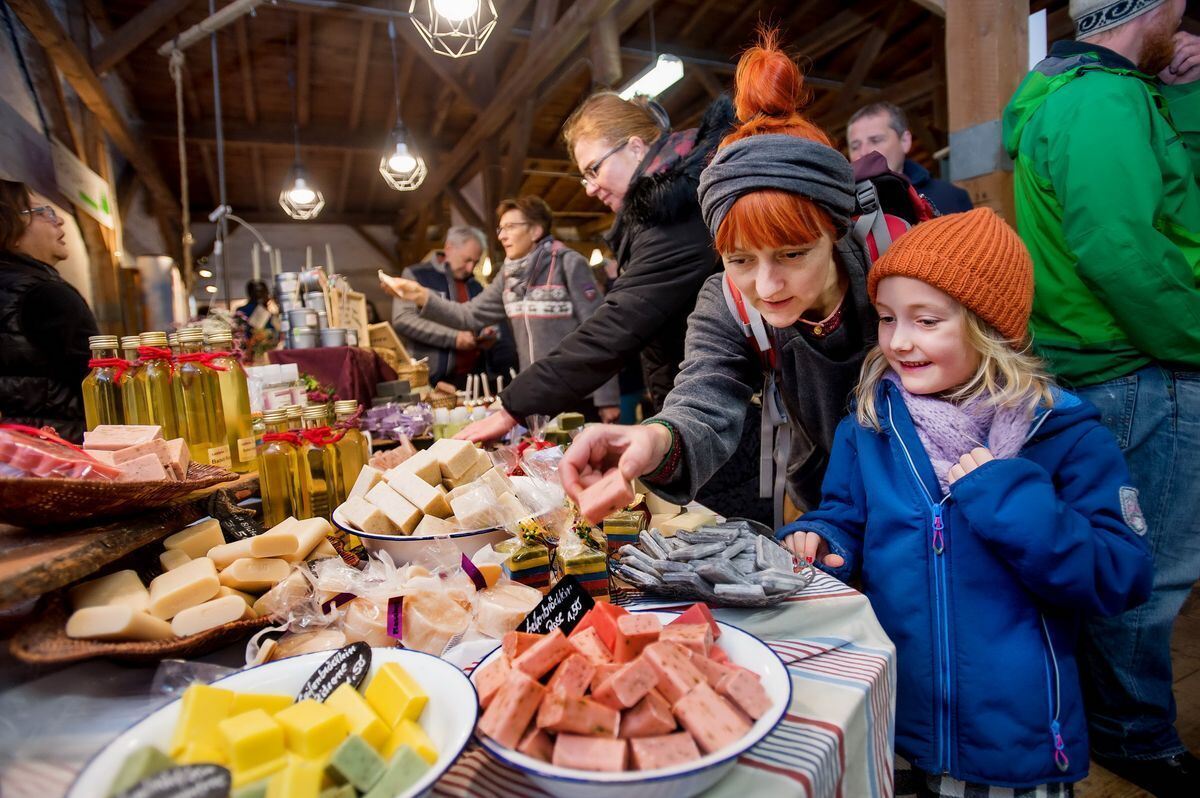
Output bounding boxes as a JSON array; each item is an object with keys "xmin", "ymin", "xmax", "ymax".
[{"xmin": 174, "ymin": 326, "xmax": 233, "ymax": 468}]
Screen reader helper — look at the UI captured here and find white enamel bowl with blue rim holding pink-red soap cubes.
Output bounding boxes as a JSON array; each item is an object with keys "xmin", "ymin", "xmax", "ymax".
[{"xmin": 474, "ymin": 612, "xmax": 792, "ymax": 798}]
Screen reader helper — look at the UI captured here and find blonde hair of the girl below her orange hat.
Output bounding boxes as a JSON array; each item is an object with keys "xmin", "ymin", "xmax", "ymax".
[{"xmin": 854, "ymin": 307, "xmax": 1054, "ymax": 431}]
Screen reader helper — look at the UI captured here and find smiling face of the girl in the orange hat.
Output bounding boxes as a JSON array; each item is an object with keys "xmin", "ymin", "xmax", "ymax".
[{"xmin": 875, "ymin": 276, "xmax": 982, "ymax": 395}]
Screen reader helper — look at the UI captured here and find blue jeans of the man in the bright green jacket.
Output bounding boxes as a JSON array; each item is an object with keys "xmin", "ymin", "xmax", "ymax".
[{"xmin": 1076, "ymin": 366, "xmax": 1200, "ymax": 760}]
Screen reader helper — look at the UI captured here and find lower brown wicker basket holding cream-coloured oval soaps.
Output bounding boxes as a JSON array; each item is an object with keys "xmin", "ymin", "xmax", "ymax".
[{"xmin": 8, "ymin": 594, "xmax": 271, "ymax": 665}]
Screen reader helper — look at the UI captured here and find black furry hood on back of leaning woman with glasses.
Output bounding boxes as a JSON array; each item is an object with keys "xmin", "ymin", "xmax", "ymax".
[{"xmin": 606, "ymin": 94, "xmax": 736, "ymax": 244}]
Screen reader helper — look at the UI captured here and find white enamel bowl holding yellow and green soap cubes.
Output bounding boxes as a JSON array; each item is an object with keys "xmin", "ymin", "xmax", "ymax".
[{"xmin": 66, "ymin": 648, "xmax": 479, "ymax": 798}]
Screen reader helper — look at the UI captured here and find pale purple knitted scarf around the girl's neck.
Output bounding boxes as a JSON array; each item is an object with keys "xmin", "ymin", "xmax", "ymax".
[{"xmin": 884, "ymin": 372, "xmax": 1032, "ymax": 493}]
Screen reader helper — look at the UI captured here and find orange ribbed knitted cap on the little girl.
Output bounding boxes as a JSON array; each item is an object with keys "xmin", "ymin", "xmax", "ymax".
[{"xmin": 866, "ymin": 208, "xmax": 1033, "ymax": 341}]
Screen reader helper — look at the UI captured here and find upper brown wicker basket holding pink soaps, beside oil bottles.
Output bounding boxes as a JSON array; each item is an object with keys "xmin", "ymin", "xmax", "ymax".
[{"xmin": 0, "ymin": 463, "xmax": 238, "ymax": 527}]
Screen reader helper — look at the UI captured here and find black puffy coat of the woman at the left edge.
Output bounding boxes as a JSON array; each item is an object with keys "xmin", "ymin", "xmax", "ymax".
[{"xmin": 0, "ymin": 252, "xmax": 100, "ymax": 442}]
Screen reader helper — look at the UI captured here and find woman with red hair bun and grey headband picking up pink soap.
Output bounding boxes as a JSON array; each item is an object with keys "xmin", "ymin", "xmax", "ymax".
[{"xmin": 562, "ymin": 31, "xmax": 877, "ymax": 522}]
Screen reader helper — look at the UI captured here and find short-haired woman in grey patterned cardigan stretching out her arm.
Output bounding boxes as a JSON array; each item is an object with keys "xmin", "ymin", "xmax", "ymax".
[{"xmin": 379, "ymin": 197, "xmax": 620, "ymax": 422}]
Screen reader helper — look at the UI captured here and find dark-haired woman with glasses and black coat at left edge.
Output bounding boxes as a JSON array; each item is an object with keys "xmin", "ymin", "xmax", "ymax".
[{"xmin": 0, "ymin": 180, "xmax": 100, "ymax": 442}]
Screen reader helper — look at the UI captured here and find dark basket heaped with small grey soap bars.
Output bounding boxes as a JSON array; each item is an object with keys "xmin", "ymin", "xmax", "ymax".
[{"xmin": 612, "ymin": 521, "xmax": 815, "ymax": 607}]
